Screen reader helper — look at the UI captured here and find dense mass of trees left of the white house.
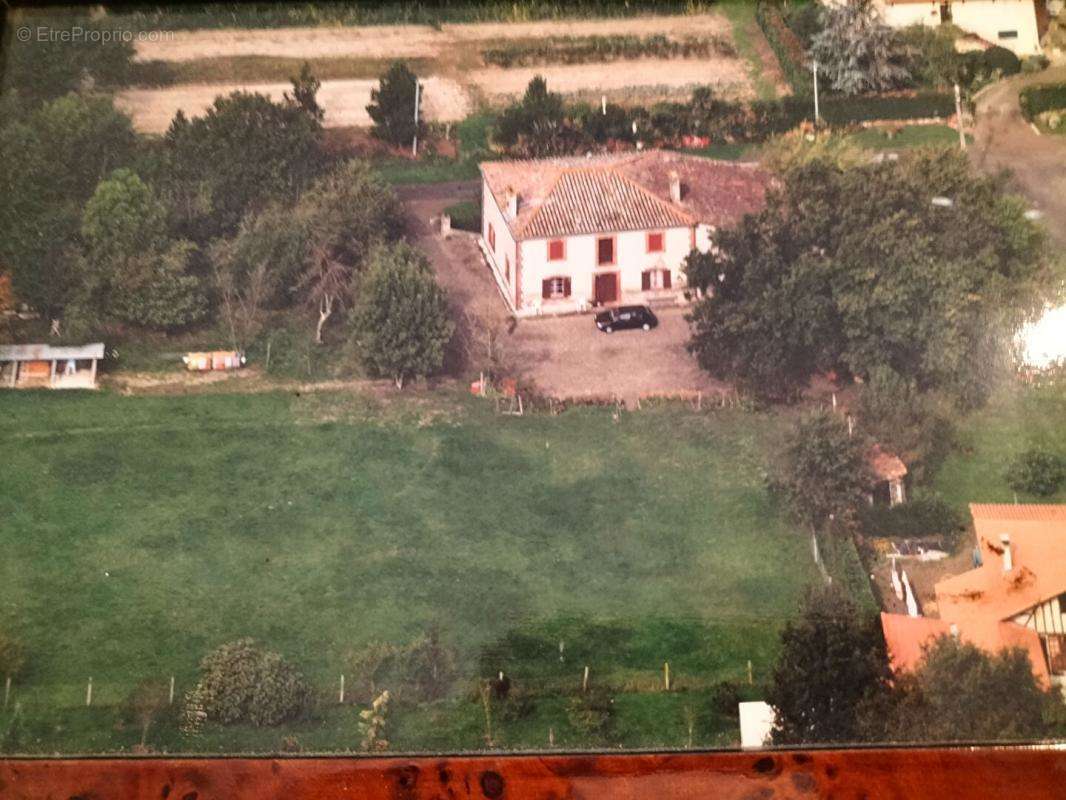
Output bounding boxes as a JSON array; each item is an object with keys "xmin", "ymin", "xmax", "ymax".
[{"xmin": 0, "ymin": 67, "xmax": 453, "ymax": 386}]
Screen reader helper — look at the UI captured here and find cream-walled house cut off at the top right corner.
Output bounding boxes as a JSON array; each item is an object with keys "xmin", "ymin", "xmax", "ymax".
[{"xmin": 875, "ymin": 0, "xmax": 1048, "ymax": 55}]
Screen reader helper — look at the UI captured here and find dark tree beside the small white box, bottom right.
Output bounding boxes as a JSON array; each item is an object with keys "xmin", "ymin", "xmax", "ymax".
[{"xmin": 766, "ymin": 586, "xmax": 889, "ymax": 745}]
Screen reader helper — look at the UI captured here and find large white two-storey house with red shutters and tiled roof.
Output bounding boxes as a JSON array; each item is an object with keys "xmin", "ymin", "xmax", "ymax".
[{"xmin": 481, "ymin": 150, "xmax": 772, "ymax": 316}]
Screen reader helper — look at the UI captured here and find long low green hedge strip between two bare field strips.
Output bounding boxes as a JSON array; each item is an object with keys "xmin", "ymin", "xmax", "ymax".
[{"xmin": 481, "ymin": 34, "xmax": 737, "ymax": 67}]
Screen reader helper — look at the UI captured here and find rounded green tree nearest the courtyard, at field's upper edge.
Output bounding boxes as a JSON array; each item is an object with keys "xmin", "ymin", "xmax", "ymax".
[{"xmin": 352, "ymin": 242, "xmax": 455, "ymax": 388}]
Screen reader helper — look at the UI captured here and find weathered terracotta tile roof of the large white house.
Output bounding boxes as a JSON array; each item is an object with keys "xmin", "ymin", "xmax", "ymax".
[{"xmin": 481, "ymin": 150, "xmax": 773, "ymax": 239}]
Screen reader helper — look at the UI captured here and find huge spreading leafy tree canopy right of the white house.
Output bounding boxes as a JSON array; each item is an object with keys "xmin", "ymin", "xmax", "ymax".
[{"xmin": 689, "ymin": 150, "xmax": 1050, "ymax": 404}]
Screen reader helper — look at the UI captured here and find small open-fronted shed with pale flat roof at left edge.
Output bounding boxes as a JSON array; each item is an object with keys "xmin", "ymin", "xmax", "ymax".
[{"xmin": 0, "ymin": 342, "xmax": 103, "ymax": 389}]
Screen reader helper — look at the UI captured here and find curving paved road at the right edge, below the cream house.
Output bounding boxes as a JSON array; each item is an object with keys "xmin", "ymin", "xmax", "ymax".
[{"xmin": 970, "ymin": 66, "xmax": 1066, "ymax": 246}]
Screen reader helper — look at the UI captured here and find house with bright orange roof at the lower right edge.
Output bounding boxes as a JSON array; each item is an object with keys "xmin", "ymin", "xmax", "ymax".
[{"xmin": 881, "ymin": 503, "xmax": 1066, "ymax": 689}]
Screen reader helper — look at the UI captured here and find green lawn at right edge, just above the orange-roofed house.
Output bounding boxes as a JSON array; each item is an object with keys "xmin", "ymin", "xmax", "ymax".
[{"xmin": 934, "ymin": 385, "xmax": 1066, "ymax": 509}]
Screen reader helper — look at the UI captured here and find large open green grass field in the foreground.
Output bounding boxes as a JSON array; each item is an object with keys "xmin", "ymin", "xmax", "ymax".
[{"xmin": 0, "ymin": 393, "xmax": 815, "ymax": 753}]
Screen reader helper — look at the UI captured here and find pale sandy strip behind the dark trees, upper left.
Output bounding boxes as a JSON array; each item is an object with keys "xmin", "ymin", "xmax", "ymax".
[{"xmin": 115, "ymin": 77, "xmax": 472, "ymax": 133}]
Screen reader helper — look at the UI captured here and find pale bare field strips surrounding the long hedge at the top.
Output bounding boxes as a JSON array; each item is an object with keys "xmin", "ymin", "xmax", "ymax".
[{"xmin": 118, "ymin": 14, "xmax": 752, "ymax": 133}]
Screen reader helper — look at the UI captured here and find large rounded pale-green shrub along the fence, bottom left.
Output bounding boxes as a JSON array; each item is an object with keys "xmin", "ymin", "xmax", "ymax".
[{"xmin": 185, "ymin": 639, "xmax": 311, "ymax": 726}]
